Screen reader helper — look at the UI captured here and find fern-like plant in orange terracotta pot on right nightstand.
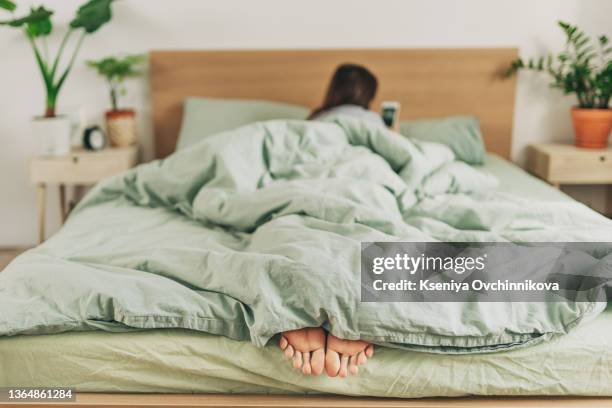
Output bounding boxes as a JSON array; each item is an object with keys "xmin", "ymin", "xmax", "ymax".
[{"xmin": 507, "ymin": 21, "xmax": 612, "ymax": 148}]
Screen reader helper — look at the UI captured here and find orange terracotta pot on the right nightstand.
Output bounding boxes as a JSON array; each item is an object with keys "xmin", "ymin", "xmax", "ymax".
[{"xmin": 572, "ymin": 108, "xmax": 612, "ymax": 149}]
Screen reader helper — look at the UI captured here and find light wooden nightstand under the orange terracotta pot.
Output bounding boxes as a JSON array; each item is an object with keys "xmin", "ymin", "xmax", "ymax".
[{"xmin": 527, "ymin": 143, "xmax": 612, "ymax": 188}]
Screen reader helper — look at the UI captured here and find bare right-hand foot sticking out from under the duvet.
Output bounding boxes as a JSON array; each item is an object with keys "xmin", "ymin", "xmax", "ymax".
[{"xmin": 325, "ymin": 334, "xmax": 374, "ymax": 378}]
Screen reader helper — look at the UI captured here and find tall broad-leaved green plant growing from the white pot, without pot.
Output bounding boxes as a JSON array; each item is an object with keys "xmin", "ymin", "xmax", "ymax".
[{"xmin": 0, "ymin": 0, "xmax": 114, "ymax": 118}]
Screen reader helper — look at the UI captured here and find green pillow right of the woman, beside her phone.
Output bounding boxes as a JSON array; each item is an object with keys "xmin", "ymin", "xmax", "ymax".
[{"xmin": 400, "ymin": 116, "xmax": 486, "ymax": 164}]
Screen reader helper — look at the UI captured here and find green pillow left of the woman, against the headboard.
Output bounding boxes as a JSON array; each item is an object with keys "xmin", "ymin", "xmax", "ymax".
[{"xmin": 176, "ymin": 97, "xmax": 310, "ymax": 150}]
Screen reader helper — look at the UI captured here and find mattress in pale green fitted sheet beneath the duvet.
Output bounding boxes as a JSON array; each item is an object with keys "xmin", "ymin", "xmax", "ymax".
[{"xmin": 0, "ymin": 156, "xmax": 612, "ymax": 398}]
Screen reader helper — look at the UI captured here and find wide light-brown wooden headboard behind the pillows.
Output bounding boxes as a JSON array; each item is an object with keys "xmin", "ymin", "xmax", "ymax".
[{"xmin": 150, "ymin": 48, "xmax": 518, "ymax": 158}]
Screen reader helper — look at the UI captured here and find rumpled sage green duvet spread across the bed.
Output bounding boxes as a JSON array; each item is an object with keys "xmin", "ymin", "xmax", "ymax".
[{"xmin": 0, "ymin": 118, "xmax": 612, "ymax": 353}]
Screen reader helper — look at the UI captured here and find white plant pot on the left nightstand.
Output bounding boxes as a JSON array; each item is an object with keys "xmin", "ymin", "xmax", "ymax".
[{"xmin": 32, "ymin": 116, "xmax": 71, "ymax": 156}]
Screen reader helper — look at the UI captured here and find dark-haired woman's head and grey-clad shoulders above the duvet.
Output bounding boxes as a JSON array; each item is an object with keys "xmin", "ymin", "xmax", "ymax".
[{"xmin": 308, "ymin": 64, "xmax": 384, "ymax": 126}]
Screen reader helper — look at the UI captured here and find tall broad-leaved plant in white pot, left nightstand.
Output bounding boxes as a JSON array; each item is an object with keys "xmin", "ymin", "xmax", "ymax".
[{"xmin": 0, "ymin": 0, "xmax": 114, "ymax": 155}]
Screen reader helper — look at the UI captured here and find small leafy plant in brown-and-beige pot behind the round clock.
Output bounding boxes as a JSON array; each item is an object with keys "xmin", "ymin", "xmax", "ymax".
[{"xmin": 87, "ymin": 55, "xmax": 145, "ymax": 147}]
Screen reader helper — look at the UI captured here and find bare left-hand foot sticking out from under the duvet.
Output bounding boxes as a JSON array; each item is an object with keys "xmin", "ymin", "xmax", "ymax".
[{"xmin": 279, "ymin": 327, "xmax": 325, "ymax": 375}]
